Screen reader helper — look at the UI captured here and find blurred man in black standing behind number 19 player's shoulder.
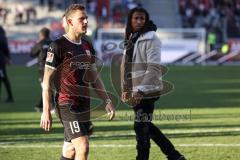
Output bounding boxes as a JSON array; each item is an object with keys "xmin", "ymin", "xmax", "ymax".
[{"xmin": 31, "ymin": 28, "xmax": 52, "ymax": 111}]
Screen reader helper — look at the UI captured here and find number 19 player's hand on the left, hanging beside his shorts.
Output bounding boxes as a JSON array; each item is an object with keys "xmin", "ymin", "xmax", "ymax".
[{"xmin": 40, "ymin": 111, "xmax": 52, "ymax": 132}]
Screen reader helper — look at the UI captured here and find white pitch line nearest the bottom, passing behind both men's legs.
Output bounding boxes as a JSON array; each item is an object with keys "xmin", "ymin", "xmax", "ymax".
[{"xmin": 0, "ymin": 143, "xmax": 240, "ymax": 148}]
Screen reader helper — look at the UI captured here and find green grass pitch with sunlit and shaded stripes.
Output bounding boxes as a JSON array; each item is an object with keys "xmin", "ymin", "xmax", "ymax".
[{"xmin": 0, "ymin": 66, "xmax": 240, "ymax": 160}]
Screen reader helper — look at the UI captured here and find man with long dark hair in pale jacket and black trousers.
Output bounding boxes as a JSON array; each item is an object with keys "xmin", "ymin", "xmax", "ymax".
[{"xmin": 121, "ymin": 8, "xmax": 185, "ymax": 160}]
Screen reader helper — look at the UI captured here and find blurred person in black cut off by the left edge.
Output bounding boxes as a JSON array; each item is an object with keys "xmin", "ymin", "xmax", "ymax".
[{"xmin": 0, "ymin": 26, "xmax": 14, "ymax": 102}]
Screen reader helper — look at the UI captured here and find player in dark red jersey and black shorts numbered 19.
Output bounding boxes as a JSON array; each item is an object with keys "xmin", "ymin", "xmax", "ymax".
[{"xmin": 40, "ymin": 4, "xmax": 115, "ymax": 160}]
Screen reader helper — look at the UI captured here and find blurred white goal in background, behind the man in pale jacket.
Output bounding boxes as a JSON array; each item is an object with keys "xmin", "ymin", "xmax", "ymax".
[{"xmin": 94, "ymin": 28, "xmax": 206, "ymax": 64}]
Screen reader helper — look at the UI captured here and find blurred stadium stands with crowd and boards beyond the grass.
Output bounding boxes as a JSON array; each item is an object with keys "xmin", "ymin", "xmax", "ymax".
[{"xmin": 0, "ymin": 0, "xmax": 240, "ymax": 64}]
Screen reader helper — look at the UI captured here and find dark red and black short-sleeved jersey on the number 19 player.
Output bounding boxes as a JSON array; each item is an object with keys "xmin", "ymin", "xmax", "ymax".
[{"xmin": 45, "ymin": 36, "xmax": 95, "ymax": 109}]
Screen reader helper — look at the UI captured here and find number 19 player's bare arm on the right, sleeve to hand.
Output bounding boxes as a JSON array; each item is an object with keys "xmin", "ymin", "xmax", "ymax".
[{"xmin": 89, "ymin": 63, "xmax": 115, "ymax": 120}]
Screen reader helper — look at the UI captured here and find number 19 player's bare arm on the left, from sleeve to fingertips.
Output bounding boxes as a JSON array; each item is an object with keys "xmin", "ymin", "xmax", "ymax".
[{"xmin": 40, "ymin": 67, "xmax": 55, "ymax": 131}]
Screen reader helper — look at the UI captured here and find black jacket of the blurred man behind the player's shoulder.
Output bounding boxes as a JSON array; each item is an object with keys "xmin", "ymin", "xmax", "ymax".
[{"xmin": 30, "ymin": 39, "xmax": 52, "ymax": 70}]
